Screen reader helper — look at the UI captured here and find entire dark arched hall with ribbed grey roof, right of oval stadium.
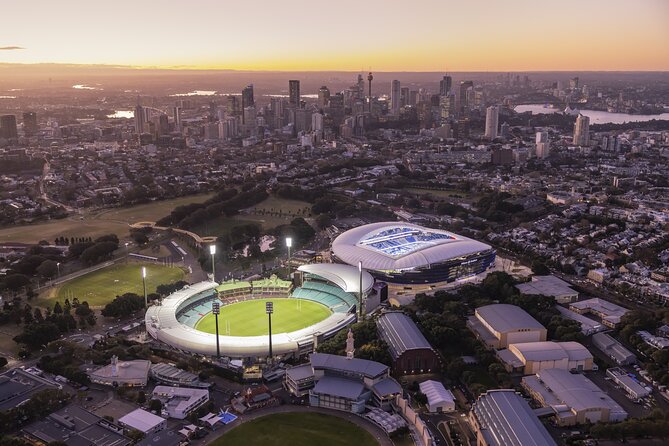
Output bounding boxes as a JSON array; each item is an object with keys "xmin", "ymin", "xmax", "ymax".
[{"xmin": 376, "ymin": 311, "xmax": 441, "ymax": 375}]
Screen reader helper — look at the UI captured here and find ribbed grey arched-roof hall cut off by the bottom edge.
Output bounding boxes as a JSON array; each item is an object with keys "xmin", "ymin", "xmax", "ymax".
[{"xmin": 469, "ymin": 389, "xmax": 557, "ymax": 446}]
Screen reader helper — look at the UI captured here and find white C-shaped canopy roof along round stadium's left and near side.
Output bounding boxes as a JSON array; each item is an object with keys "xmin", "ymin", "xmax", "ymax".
[{"xmin": 145, "ymin": 281, "xmax": 356, "ymax": 358}]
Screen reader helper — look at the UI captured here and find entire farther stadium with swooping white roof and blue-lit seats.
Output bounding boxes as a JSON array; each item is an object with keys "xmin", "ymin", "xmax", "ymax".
[{"xmin": 332, "ymin": 222, "xmax": 495, "ymax": 285}]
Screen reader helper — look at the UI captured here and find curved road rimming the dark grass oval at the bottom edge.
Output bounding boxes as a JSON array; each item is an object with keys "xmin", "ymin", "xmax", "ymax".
[{"xmin": 201, "ymin": 405, "xmax": 394, "ymax": 446}]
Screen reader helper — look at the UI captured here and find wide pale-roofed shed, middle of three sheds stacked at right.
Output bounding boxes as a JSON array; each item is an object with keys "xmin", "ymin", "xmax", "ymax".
[{"xmin": 497, "ymin": 341, "xmax": 593, "ymax": 375}]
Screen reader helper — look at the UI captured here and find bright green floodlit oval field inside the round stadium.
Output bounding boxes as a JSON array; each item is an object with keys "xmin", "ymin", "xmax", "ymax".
[{"xmin": 195, "ymin": 298, "xmax": 331, "ymax": 336}]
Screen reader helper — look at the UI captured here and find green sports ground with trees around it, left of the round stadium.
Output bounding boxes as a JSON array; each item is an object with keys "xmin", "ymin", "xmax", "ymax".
[{"xmin": 37, "ymin": 263, "xmax": 185, "ymax": 306}]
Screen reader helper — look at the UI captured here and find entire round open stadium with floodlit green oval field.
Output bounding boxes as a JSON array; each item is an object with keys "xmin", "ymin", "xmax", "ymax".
[{"xmin": 145, "ymin": 264, "xmax": 378, "ymax": 359}]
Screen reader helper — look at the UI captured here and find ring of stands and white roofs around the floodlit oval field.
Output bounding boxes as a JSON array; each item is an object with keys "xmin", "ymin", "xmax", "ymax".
[{"xmin": 145, "ymin": 264, "xmax": 374, "ymax": 359}]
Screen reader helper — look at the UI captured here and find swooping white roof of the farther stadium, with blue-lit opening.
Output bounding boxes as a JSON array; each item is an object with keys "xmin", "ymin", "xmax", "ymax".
[{"xmin": 332, "ymin": 222, "xmax": 491, "ymax": 271}]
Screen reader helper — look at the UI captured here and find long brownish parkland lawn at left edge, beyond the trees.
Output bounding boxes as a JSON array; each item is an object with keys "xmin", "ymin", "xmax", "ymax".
[{"xmin": 0, "ymin": 194, "xmax": 213, "ymax": 243}]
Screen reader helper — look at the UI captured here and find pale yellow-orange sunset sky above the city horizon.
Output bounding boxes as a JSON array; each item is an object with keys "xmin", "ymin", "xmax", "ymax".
[{"xmin": 0, "ymin": 0, "xmax": 669, "ymax": 72}]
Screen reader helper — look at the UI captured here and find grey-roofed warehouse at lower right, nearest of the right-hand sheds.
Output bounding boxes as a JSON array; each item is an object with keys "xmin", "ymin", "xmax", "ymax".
[{"xmin": 522, "ymin": 369, "xmax": 627, "ymax": 426}]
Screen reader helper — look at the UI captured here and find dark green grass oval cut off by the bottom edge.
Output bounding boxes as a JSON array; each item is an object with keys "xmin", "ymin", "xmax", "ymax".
[{"xmin": 211, "ymin": 412, "xmax": 379, "ymax": 446}]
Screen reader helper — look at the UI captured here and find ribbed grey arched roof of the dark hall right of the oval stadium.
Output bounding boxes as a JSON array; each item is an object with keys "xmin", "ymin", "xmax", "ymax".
[{"xmin": 376, "ymin": 311, "xmax": 432, "ymax": 359}]
